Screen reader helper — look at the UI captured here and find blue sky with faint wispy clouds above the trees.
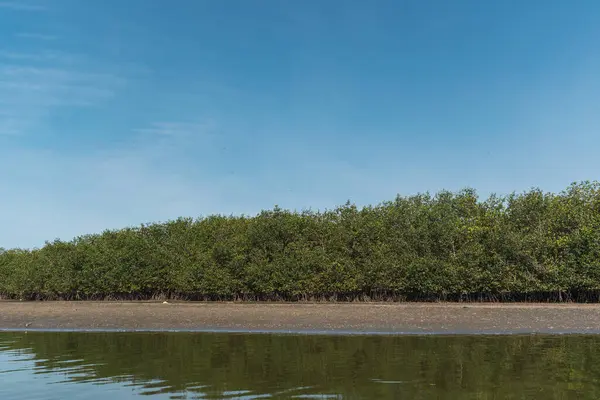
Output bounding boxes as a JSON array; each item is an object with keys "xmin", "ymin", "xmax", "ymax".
[{"xmin": 0, "ymin": 0, "xmax": 600, "ymax": 248}]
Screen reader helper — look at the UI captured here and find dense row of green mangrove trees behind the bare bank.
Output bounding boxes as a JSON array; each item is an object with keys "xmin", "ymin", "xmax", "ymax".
[{"xmin": 0, "ymin": 182, "xmax": 600, "ymax": 301}]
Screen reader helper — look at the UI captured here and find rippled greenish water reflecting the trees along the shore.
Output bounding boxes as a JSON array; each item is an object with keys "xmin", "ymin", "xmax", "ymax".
[{"xmin": 0, "ymin": 332, "xmax": 600, "ymax": 399}]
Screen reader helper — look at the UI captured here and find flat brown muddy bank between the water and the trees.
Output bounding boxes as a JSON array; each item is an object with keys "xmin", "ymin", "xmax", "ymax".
[{"xmin": 0, "ymin": 301, "xmax": 600, "ymax": 334}]
